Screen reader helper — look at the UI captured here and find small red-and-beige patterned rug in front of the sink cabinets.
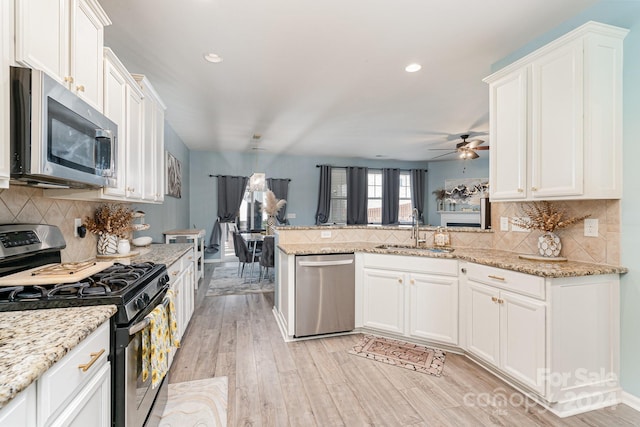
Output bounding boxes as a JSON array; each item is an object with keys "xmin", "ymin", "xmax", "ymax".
[{"xmin": 349, "ymin": 335, "xmax": 446, "ymax": 377}]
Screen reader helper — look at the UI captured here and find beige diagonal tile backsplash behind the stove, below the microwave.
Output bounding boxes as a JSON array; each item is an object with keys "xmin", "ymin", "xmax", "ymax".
[{"xmin": 0, "ymin": 185, "xmax": 106, "ymax": 262}]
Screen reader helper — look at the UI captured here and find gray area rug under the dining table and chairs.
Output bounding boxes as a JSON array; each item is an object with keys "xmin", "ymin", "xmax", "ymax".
[{"xmin": 207, "ymin": 263, "xmax": 274, "ymax": 297}]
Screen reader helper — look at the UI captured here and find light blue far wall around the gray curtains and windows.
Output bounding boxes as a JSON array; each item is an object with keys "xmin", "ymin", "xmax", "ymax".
[{"xmin": 190, "ymin": 151, "xmax": 429, "ymax": 260}]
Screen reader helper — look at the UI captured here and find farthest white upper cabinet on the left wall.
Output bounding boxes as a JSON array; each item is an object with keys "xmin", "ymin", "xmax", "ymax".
[{"xmin": 133, "ymin": 74, "xmax": 167, "ymax": 202}]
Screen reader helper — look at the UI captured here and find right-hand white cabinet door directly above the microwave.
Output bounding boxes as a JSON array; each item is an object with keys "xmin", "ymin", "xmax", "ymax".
[{"xmin": 69, "ymin": 0, "xmax": 104, "ymax": 111}]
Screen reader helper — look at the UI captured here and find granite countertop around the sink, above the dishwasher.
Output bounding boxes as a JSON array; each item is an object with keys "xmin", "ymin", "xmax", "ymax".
[{"xmin": 278, "ymin": 242, "xmax": 628, "ymax": 278}]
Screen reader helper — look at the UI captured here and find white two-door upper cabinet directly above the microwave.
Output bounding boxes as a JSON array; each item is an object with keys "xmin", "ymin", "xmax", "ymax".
[{"xmin": 15, "ymin": 0, "xmax": 111, "ymax": 111}]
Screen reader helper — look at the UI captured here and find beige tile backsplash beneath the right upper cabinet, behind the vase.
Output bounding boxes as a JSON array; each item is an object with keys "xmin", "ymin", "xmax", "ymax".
[{"xmin": 491, "ymin": 200, "xmax": 620, "ymax": 265}]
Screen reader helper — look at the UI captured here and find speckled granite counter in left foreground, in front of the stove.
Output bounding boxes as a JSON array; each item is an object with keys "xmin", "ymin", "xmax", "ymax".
[{"xmin": 0, "ymin": 305, "xmax": 117, "ymax": 408}]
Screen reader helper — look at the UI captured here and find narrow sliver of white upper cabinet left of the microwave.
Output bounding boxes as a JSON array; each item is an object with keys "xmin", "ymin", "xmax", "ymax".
[{"xmin": 0, "ymin": 1, "xmax": 13, "ymax": 188}]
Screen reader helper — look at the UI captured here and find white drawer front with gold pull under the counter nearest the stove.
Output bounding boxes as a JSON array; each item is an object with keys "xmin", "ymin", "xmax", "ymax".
[{"xmin": 37, "ymin": 321, "xmax": 110, "ymax": 426}]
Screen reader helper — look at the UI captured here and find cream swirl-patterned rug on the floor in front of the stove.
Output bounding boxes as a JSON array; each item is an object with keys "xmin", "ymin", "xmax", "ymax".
[{"xmin": 159, "ymin": 377, "xmax": 228, "ymax": 427}]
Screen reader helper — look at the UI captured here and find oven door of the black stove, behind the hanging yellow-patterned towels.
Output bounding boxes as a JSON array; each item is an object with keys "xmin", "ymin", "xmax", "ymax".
[{"xmin": 113, "ymin": 289, "xmax": 168, "ymax": 427}]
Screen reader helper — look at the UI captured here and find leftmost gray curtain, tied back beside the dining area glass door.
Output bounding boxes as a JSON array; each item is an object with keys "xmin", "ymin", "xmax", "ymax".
[{"xmin": 206, "ymin": 175, "xmax": 249, "ymax": 254}]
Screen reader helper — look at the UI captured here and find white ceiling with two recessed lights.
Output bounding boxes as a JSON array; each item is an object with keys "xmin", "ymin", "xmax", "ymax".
[{"xmin": 100, "ymin": 0, "xmax": 596, "ymax": 160}]
